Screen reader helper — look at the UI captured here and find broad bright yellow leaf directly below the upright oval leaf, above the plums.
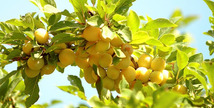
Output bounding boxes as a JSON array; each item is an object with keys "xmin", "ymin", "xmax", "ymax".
[{"xmin": 130, "ymin": 31, "xmax": 150, "ymax": 44}]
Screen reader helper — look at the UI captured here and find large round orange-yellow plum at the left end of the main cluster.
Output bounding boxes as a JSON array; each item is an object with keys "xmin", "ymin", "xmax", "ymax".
[{"xmin": 59, "ymin": 49, "xmax": 75, "ymax": 65}]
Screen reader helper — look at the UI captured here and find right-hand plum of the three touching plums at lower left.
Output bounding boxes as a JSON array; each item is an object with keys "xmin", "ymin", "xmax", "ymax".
[{"xmin": 41, "ymin": 64, "xmax": 56, "ymax": 75}]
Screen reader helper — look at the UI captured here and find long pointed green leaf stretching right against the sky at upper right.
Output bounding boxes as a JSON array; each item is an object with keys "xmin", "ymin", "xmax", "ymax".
[{"xmin": 143, "ymin": 18, "xmax": 177, "ymax": 30}]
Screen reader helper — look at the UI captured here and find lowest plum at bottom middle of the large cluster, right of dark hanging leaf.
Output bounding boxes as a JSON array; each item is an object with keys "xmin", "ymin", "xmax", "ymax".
[{"xmin": 103, "ymin": 76, "xmax": 114, "ymax": 90}]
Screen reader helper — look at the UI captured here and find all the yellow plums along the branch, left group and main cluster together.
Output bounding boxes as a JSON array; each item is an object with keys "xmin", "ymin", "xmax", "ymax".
[{"xmin": 23, "ymin": 26, "xmax": 186, "ymax": 93}]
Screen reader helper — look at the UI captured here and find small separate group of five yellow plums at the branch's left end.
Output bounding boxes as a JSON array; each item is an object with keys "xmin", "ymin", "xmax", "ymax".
[{"xmin": 22, "ymin": 28, "xmax": 56, "ymax": 78}]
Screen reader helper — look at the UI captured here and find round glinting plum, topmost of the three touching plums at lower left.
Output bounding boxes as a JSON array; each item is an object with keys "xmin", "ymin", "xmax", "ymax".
[{"xmin": 27, "ymin": 57, "xmax": 45, "ymax": 70}]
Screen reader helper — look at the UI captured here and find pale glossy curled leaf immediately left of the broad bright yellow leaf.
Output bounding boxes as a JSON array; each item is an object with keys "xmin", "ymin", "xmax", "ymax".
[{"xmin": 118, "ymin": 27, "xmax": 132, "ymax": 42}]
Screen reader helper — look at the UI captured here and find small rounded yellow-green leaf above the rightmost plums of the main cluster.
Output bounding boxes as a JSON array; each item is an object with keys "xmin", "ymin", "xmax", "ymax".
[{"xmin": 160, "ymin": 34, "xmax": 175, "ymax": 45}]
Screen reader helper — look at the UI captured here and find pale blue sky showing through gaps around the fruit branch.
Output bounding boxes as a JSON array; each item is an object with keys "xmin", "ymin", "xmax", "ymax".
[{"xmin": 0, "ymin": 0, "xmax": 213, "ymax": 108}]
